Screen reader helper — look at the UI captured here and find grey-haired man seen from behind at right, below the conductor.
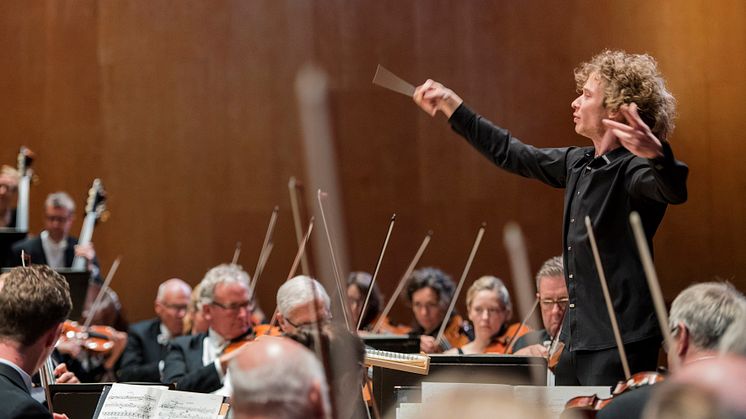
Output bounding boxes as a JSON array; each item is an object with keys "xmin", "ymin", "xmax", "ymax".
[{"xmin": 598, "ymin": 282, "xmax": 746, "ymax": 418}]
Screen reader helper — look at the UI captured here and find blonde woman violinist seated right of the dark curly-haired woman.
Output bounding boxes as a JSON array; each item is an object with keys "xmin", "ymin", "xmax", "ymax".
[{"xmin": 446, "ymin": 276, "xmax": 530, "ymax": 355}]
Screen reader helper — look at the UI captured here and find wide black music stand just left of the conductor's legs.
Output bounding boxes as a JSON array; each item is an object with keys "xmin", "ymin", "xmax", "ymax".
[{"xmin": 373, "ymin": 354, "xmax": 547, "ymax": 412}]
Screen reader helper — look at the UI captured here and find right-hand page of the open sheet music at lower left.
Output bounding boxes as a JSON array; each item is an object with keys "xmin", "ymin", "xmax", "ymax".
[{"xmin": 153, "ymin": 390, "xmax": 223, "ymax": 419}]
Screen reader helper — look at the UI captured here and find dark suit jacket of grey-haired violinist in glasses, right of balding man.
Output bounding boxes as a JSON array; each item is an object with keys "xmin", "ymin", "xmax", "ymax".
[{"xmin": 163, "ymin": 333, "xmax": 223, "ymax": 393}]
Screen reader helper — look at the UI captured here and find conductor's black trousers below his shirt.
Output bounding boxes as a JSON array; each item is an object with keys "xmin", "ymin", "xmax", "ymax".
[{"xmin": 554, "ymin": 337, "xmax": 661, "ymax": 386}]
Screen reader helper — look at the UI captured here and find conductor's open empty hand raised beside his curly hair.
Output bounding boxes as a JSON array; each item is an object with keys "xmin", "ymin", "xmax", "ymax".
[{"xmin": 603, "ymin": 103, "xmax": 663, "ymax": 159}]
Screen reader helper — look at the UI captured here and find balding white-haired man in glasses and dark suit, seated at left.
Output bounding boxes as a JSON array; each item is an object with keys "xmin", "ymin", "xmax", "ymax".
[{"xmin": 117, "ymin": 278, "xmax": 192, "ymax": 383}]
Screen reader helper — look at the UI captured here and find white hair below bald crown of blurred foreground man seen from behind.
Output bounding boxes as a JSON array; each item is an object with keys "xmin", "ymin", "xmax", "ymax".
[{"xmin": 228, "ymin": 344, "xmax": 330, "ymax": 419}]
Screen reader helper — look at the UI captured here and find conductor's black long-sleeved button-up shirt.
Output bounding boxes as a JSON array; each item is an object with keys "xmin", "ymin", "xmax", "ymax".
[{"xmin": 449, "ymin": 104, "xmax": 689, "ymax": 350}]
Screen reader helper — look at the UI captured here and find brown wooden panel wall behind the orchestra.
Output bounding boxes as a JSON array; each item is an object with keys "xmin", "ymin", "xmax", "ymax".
[{"xmin": 0, "ymin": 0, "xmax": 746, "ymax": 320}]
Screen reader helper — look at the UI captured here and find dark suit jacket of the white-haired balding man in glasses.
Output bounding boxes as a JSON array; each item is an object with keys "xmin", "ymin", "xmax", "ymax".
[{"xmin": 117, "ymin": 318, "xmax": 167, "ymax": 383}]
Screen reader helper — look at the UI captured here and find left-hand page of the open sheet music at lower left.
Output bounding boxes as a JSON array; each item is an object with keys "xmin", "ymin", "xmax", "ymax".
[{"xmin": 98, "ymin": 383, "xmax": 168, "ymax": 419}]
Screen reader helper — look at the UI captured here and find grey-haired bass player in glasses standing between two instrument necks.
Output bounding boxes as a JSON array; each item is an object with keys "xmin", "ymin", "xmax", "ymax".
[{"xmin": 12, "ymin": 192, "xmax": 102, "ymax": 283}]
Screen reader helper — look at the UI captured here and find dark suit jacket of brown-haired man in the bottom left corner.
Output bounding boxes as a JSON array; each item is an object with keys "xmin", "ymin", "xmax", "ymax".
[{"xmin": 0, "ymin": 364, "xmax": 52, "ymax": 419}]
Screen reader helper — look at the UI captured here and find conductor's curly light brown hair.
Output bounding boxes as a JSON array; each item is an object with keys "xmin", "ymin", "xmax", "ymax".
[{"xmin": 575, "ymin": 50, "xmax": 676, "ymax": 140}]
